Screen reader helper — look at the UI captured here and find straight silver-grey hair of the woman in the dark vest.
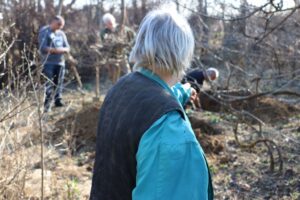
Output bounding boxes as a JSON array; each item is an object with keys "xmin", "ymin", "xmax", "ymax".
[{"xmin": 129, "ymin": 9, "xmax": 195, "ymax": 75}]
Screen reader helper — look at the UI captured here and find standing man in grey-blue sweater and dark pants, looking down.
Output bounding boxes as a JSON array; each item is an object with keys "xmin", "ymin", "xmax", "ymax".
[{"xmin": 38, "ymin": 16, "xmax": 70, "ymax": 112}]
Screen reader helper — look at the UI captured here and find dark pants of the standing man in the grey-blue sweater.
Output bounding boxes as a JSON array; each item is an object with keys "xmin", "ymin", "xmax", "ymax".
[{"xmin": 43, "ymin": 64, "xmax": 65, "ymax": 108}]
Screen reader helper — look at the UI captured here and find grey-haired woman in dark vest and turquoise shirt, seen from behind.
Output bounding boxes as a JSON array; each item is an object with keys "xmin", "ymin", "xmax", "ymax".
[{"xmin": 90, "ymin": 7, "xmax": 213, "ymax": 200}]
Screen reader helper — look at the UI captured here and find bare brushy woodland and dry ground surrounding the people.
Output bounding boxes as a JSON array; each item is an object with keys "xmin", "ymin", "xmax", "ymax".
[{"xmin": 0, "ymin": 0, "xmax": 300, "ymax": 199}]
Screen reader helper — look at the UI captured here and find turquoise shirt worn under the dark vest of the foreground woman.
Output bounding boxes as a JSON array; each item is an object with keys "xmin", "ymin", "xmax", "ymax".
[{"xmin": 132, "ymin": 68, "xmax": 209, "ymax": 200}]
